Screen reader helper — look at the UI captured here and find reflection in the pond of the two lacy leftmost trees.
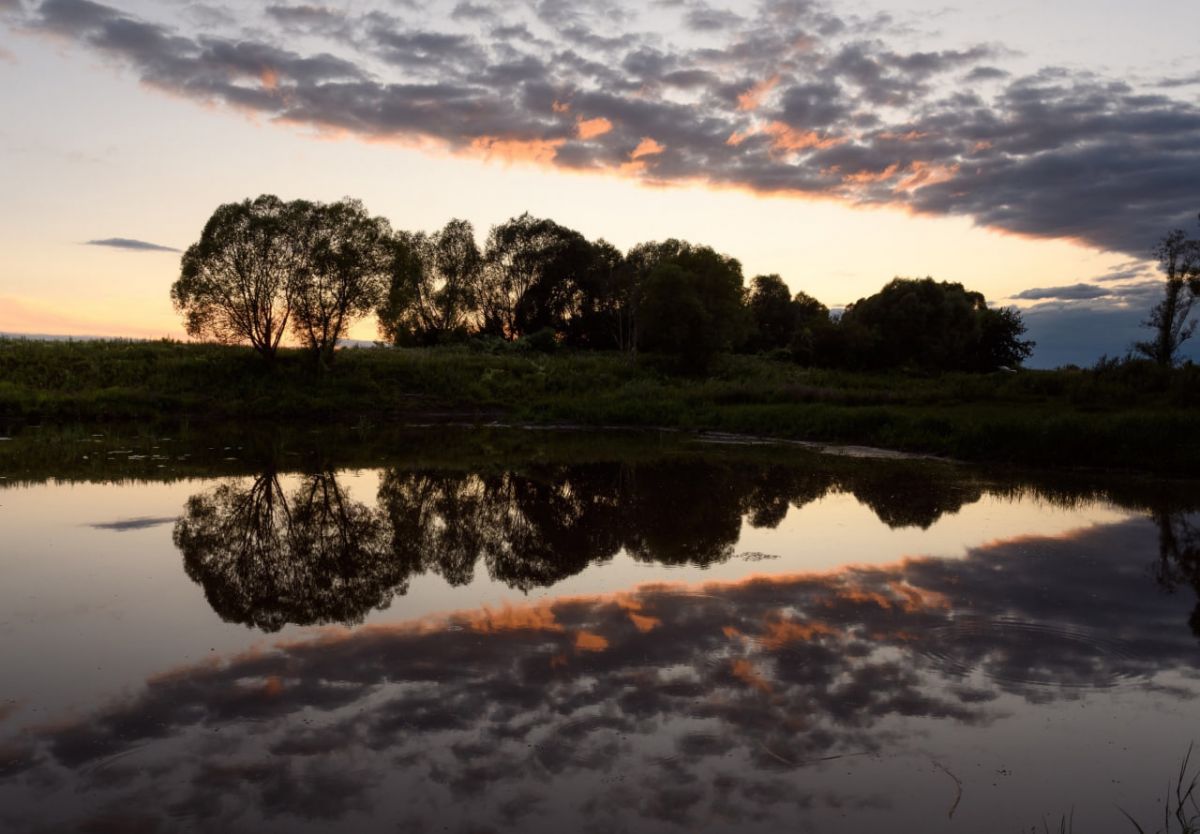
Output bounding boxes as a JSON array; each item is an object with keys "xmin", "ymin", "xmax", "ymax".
[{"xmin": 174, "ymin": 473, "xmax": 398, "ymax": 631}]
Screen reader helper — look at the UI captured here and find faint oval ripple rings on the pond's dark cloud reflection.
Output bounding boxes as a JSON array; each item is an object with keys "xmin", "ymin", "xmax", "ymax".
[{"xmin": 919, "ymin": 618, "xmax": 1141, "ymax": 689}]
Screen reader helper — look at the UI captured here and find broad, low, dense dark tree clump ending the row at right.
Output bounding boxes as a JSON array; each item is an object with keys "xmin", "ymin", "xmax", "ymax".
[{"xmin": 839, "ymin": 278, "xmax": 1033, "ymax": 371}]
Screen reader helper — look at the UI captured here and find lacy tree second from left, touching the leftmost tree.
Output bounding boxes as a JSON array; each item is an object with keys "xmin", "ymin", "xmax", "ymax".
[{"xmin": 292, "ymin": 199, "xmax": 391, "ymax": 367}]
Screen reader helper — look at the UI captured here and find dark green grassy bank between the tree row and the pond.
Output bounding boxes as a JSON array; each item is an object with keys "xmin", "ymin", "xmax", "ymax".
[{"xmin": 0, "ymin": 341, "xmax": 1200, "ymax": 474}]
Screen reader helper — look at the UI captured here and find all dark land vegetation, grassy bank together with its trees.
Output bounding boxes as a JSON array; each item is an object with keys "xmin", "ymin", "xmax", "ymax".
[{"xmin": 0, "ymin": 196, "xmax": 1200, "ymax": 473}]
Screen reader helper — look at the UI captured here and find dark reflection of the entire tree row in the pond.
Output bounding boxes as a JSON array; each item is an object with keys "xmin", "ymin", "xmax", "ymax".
[{"xmin": 175, "ymin": 460, "xmax": 983, "ymax": 631}]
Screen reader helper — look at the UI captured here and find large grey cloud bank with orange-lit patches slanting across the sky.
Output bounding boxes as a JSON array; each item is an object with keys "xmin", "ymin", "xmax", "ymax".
[{"xmin": 10, "ymin": 0, "xmax": 1200, "ymax": 257}]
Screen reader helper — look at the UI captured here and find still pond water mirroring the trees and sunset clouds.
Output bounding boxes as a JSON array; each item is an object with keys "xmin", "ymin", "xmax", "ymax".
[{"xmin": 0, "ymin": 428, "xmax": 1200, "ymax": 834}]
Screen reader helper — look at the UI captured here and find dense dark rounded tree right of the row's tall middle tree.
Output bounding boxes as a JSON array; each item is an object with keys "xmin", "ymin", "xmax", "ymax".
[{"xmin": 631, "ymin": 240, "xmax": 748, "ymax": 371}]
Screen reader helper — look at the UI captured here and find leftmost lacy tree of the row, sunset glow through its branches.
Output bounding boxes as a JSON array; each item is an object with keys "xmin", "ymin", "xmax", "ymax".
[{"xmin": 170, "ymin": 194, "xmax": 311, "ymax": 360}]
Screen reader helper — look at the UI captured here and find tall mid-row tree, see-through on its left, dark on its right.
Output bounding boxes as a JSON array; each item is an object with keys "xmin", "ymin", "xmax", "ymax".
[{"xmin": 479, "ymin": 214, "xmax": 593, "ymax": 340}]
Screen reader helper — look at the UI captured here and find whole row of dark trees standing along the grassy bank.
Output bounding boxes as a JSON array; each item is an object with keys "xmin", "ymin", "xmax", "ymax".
[{"xmin": 172, "ymin": 194, "xmax": 1032, "ymax": 371}]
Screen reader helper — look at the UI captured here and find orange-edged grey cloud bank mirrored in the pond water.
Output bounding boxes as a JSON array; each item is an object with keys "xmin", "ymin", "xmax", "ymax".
[{"xmin": 0, "ymin": 518, "xmax": 1198, "ymax": 830}]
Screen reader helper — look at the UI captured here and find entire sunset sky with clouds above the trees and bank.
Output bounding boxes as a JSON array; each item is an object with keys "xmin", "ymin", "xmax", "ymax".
[{"xmin": 0, "ymin": 0, "xmax": 1200, "ymax": 366}]
